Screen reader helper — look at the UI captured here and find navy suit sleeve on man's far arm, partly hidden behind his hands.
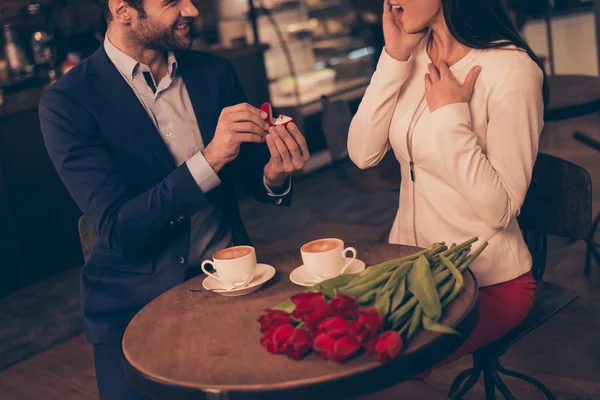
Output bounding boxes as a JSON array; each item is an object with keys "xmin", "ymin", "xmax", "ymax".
[{"xmin": 227, "ymin": 63, "xmax": 293, "ymax": 206}]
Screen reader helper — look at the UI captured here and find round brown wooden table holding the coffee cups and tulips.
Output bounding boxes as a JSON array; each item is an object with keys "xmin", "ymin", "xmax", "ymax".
[{"xmin": 122, "ymin": 244, "xmax": 479, "ymax": 400}]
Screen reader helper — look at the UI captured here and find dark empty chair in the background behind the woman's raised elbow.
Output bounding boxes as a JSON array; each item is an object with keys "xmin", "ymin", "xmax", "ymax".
[{"xmin": 321, "ymin": 96, "xmax": 400, "ymax": 192}]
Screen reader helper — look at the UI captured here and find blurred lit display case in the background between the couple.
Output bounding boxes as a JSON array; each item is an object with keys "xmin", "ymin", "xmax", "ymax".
[{"xmin": 218, "ymin": 0, "xmax": 373, "ymax": 108}]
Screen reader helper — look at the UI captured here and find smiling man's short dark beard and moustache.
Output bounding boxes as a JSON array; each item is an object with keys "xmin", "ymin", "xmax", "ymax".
[{"xmin": 130, "ymin": 18, "xmax": 192, "ymax": 52}]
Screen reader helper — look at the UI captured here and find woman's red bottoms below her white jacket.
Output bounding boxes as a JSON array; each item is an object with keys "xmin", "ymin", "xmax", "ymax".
[{"xmin": 420, "ymin": 272, "xmax": 535, "ymax": 377}]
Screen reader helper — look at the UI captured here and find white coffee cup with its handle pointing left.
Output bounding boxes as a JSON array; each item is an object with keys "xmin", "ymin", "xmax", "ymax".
[{"xmin": 202, "ymin": 246, "xmax": 256, "ymax": 289}]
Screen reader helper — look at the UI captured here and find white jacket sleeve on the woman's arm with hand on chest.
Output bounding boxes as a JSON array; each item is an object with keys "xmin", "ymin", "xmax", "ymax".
[{"xmin": 427, "ymin": 68, "xmax": 544, "ymax": 229}]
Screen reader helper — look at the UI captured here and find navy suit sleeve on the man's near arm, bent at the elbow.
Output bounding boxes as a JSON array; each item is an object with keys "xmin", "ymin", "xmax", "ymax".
[{"xmin": 39, "ymin": 89, "xmax": 210, "ymax": 256}]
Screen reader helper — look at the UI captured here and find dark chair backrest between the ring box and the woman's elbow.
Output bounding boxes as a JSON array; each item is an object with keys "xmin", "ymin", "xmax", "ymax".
[{"xmin": 321, "ymin": 96, "xmax": 352, "ymax": 162}]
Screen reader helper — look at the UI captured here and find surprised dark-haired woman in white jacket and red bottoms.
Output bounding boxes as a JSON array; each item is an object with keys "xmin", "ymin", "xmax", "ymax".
[{"xmin": 348, "ymin": 0, "xmax": 547, "ymax": 368}]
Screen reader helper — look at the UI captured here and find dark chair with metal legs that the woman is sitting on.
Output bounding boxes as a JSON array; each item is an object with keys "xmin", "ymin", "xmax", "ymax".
[{"xmin": 449, "ymin": 153, "xmax": 592, "ymax": 400}]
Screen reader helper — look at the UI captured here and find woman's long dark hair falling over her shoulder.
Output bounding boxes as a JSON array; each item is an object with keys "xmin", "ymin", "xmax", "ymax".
[{"xmin": 442, "ymin": 0, "xmax": 549, "ymax": 106}]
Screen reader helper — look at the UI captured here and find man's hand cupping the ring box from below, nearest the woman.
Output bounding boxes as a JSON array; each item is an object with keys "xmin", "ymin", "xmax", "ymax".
[{"xmin": 264, "ymin": 122, "xmax": 310, "ymax": 190}]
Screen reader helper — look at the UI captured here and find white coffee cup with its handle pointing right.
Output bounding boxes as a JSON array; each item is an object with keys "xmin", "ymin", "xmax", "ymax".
[{"xmin": 300, "ymin": 238, "xmax": 356, "ymax": 279}]
